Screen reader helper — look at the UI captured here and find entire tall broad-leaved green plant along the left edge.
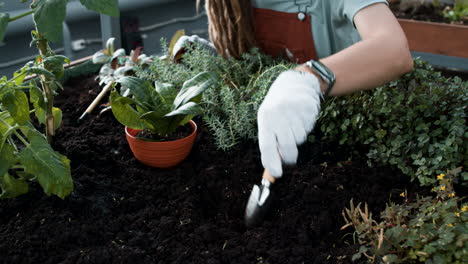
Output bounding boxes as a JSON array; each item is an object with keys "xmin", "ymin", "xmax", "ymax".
[{"xmin": 0, "ymin": 0, "xmax": 119, "ymax": 198}]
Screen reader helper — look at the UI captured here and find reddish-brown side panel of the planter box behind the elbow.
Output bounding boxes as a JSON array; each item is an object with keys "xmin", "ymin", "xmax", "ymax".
[{"xmin": 398, "ymin": 19, "xmax": 468, "ymax": 58}]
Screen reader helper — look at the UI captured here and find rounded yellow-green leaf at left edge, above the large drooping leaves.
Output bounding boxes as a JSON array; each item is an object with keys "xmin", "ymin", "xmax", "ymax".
[{"xmin": 2, "ymin": 90, "xmax": 29, "ymax": 125}]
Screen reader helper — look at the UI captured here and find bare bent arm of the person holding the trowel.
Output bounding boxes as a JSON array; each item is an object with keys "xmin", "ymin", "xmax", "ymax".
[{"xmin": 296, "ymin": 4, "xmax": 413, "ymax": 95}]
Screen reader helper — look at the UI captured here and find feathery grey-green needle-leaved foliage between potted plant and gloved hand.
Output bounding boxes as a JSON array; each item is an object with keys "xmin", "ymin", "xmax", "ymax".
[{"xmin": 137, "ymin": 41, "xmax": 293, "ymax": 150}]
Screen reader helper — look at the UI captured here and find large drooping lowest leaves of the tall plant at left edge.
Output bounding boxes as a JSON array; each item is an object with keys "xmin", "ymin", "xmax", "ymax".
[{"xmin": 0, "ymin": 104, "xmax": 73, "ymax": 198}]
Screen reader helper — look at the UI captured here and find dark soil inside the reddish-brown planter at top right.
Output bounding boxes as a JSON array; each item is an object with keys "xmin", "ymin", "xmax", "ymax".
[{"xmin": 390, "ymin": 0, "xmax": 468, "ymax": 25}]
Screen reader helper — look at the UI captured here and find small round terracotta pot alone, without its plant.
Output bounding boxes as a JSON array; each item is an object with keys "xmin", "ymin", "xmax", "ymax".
[{"xmin": 125, "ymin": 121, "xmax": 197, "ymax": 168}]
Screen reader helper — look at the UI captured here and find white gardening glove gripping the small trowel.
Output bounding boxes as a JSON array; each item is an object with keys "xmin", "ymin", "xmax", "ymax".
[{"xmin": 257, "ymin": 70, "xmax": 322, "ymax": 178}]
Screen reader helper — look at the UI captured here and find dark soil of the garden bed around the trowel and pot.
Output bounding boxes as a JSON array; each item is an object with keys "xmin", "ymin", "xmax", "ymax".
[{"xmin": 0, "ymin": 76, "xmax": 426, "ymax": 264}]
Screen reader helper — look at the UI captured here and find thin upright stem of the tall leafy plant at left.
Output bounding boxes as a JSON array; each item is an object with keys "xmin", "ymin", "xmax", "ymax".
[{"xmin": 37, "ymin": 33, "xmax": 55, "ymax": 144}]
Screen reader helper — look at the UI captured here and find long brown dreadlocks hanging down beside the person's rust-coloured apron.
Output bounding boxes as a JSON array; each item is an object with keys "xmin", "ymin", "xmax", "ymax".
[{"xmin": 197, "ymin": 0, "xmax": 255, "ymax": 58}]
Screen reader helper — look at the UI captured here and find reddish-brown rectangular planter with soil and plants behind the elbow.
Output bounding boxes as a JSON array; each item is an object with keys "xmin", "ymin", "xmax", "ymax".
[{"xmin": 390, "ymin": 0, "xmax": 468, "ymax": 58}]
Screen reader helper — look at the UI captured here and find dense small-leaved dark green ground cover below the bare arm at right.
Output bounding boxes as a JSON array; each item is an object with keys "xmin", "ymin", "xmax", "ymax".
[{"xmin": 319, "ymin": 60, "xmax": 468, "ymax": 185}]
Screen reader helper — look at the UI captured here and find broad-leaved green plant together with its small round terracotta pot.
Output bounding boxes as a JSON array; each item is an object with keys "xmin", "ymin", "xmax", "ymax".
[{"xmin": 110, "ymin": 72, "xmax": 217, "ymax": 168}]
